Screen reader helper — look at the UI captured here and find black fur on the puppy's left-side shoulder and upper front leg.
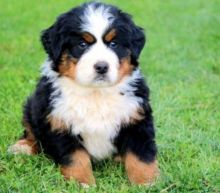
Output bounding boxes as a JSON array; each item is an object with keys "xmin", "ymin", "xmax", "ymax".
[{"xmin": 24, "ymin": 77, "xmax": 82, "ymax": 164}]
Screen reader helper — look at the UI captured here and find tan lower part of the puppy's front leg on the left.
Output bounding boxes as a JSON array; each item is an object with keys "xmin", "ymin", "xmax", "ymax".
[{"xmin": 61, "ymin": 150, "xmax": 95, "ymax": 185}]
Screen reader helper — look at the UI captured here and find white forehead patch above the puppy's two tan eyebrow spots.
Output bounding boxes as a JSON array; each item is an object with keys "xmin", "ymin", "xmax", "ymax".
[{"xmin": 82, "ymin": 4, "xmax": 113, "ymax": 38}]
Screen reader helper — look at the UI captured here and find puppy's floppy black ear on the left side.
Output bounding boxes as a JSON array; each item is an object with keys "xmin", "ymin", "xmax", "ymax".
[{"xmin": 41, "ymin": 26, "xmax": 63, "ymax": 65}]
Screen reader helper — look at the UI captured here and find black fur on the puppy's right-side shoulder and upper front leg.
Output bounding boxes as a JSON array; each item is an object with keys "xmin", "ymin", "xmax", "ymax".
[{"xmin": 115, "ymin": 79, "xmax": 157, "ymax": 162}]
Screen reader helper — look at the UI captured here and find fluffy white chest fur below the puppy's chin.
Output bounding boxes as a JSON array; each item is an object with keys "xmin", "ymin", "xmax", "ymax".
[{"xmin": 51, "ymin": 71, "xmax": 141, "ymax": 159}]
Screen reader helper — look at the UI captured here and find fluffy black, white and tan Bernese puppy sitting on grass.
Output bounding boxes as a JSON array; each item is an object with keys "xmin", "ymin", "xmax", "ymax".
[{"xmin": 9, "ymin": 2, "xmax": 158, "ymax": 185}]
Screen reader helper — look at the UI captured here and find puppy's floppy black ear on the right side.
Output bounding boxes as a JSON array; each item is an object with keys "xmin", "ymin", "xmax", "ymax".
[{"xmin": 131, "ymin": 26, "xmax": 146, "ymax": 58}]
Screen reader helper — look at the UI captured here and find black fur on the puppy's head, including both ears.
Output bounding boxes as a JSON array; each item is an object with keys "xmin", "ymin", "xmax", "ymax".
[{"xmin": 41, "ymin": 3, "xmax": 145, "ymax": 71}]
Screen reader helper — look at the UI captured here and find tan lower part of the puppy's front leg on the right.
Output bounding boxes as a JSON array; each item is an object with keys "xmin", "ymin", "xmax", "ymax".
[{"xmin": 125, "ymin": 152, "xmax": 159, "ymax": 185}]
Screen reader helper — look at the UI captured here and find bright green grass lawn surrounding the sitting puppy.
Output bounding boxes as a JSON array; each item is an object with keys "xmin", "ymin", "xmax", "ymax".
[{"xmin": 0, "ymin": 0, "xmax": 220, "ymax": 193}]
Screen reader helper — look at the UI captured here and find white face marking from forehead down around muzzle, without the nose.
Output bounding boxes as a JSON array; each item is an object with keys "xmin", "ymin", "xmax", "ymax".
[{"xmin": 75, "ymin": 3, "xmax": 119, "ymax": 86}]
